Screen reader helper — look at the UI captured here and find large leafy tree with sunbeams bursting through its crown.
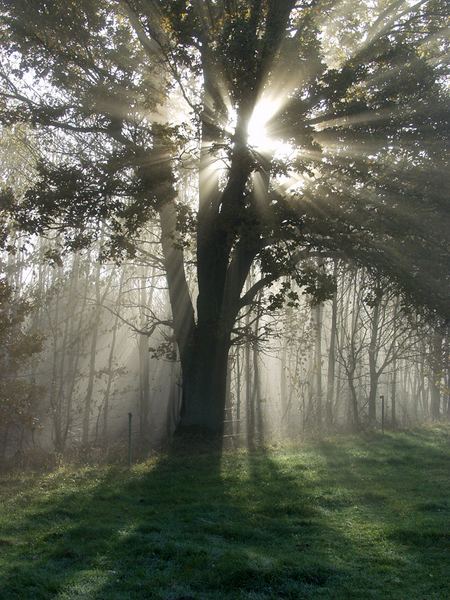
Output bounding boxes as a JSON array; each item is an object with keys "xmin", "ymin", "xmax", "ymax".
[{"xmin": 0, "ymin": 0, "xmax": 450, "ymax": 433}]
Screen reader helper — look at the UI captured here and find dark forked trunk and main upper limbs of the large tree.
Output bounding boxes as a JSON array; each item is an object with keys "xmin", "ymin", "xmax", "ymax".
[{"xmin": 159, "ymin": 0, "xmax": 294, "ymax": 434}]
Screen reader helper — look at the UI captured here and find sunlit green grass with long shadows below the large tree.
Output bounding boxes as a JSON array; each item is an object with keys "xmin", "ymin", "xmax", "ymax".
[{"xmin": 0, "ymin": 426, "xmax": 450, "ymax": 600}]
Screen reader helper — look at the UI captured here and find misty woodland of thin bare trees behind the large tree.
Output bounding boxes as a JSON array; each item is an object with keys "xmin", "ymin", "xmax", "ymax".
[{"xmin": 1, "ymin": 238, "xmax": 450, "ymax": 461}]
